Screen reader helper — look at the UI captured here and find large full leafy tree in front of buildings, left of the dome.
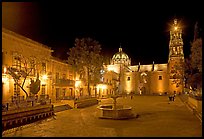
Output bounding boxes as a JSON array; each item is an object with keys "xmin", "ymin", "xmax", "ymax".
[{"xmin": 68, "ymin": 38, "xmax": 103, "ymax": 96}]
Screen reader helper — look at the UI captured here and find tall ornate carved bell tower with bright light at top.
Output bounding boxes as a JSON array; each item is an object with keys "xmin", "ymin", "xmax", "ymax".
[{"xmin": 168, "ymin": 19, "xmax": 184, "ymax": 94}]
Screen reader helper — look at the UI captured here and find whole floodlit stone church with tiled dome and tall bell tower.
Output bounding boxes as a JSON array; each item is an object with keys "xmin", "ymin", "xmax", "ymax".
[{"xmin": 103, "ymin": 19, "xmax": 184, "ymax": 95}]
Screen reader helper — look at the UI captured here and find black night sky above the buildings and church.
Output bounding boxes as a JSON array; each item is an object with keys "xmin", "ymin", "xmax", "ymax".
[{"xmin": 2, "ymin": 0, "xmax": 204, "ymax": 65}]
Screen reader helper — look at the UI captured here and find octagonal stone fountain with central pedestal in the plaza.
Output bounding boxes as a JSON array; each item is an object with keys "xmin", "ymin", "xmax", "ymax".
[{"xmin": 97, "ymin": 95, "xmax": 136, "ymax": 119}]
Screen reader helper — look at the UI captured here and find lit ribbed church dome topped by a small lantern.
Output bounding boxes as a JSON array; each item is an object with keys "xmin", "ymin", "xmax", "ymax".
[{"xmin": 112, "ymin": 48, "xmax": 130, "ymax": 65}]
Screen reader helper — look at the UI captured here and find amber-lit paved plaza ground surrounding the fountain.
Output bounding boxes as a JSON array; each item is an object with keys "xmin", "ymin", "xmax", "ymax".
[{"xmin": 2, "ymin": 96, "xmax": 202, "ymax": 137}]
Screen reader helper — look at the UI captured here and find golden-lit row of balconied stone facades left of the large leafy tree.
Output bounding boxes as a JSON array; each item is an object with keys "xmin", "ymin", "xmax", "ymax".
[{"xmin": 2, "ymin": 28, "xmax": 75, "ymax": 103}]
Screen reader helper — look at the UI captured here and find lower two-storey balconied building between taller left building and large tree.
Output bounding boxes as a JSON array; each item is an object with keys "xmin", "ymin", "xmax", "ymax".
[{"xmin": 50, "ymin": 57, "xmax": 75, "ymax": 102}]
